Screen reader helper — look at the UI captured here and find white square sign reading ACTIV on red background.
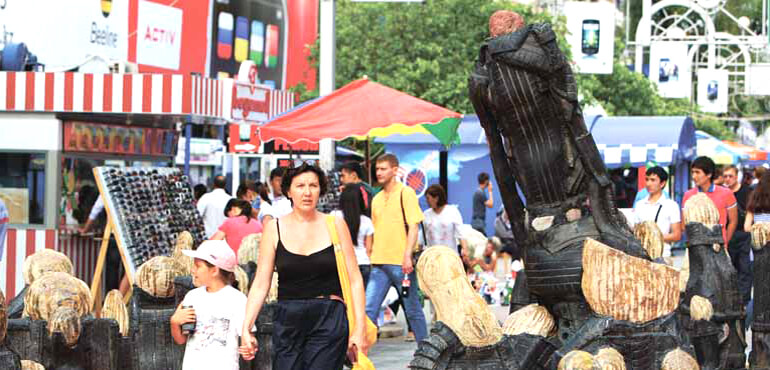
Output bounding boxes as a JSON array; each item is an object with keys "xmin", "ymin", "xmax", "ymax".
[{"xmin": 136, "ymin": 0, "xmax": 184, "ymax": 70}]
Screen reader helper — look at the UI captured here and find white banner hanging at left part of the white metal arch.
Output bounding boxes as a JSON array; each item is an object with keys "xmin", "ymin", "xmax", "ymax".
[{"xmin": 650, "ymin": 42, "xmax": 692, "ymax": 98}]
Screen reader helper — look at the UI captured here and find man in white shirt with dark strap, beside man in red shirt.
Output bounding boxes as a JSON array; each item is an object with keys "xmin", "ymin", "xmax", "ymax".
[{"xmin": 634, "ymin": 166, "xmax": 682, "ymax": 257}]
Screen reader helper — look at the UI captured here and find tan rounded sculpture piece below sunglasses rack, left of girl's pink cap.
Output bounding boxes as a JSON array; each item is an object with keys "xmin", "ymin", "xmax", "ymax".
[{"xmin": 136, "ymin": 256, "xmax": 186, "ymax": 298}]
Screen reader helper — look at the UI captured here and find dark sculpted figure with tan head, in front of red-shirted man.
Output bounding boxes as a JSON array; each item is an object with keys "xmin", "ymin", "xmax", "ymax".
[{"xmin": 679, "ymin": 192, "xmax": 746, "ymax": 369}]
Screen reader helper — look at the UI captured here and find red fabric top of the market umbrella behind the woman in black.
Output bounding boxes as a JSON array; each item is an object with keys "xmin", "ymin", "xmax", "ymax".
[{"xmin": 259, "ymin": 78, "xmax": 462, "ymax": 143}]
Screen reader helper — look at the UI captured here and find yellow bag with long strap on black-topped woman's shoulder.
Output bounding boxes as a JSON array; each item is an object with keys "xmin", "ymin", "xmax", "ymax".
[{"xmin": 326, "ymin": 215, "xmax": 377, "ymax": 370}]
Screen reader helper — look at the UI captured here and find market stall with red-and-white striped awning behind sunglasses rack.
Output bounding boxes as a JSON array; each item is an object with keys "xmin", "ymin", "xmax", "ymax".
[{"xmin": 0, "ymin": 72, "xmax": 294, "ymax": 299}]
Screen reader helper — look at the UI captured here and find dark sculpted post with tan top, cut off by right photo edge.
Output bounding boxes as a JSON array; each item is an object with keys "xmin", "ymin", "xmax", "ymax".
[{"xmin": 749, "ymin": 222, "xmax": 770, "ymax": 369}]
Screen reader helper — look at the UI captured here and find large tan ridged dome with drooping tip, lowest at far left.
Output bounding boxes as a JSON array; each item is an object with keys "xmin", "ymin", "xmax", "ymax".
[{"xmin": 24, "ymin": 272, "xmax": 92, "ymax": 346}]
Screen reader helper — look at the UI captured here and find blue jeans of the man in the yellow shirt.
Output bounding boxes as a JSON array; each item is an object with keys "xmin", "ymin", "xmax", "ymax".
[{"xmin": 366, "ymin": 265, "xmax": 428, "ymax": 342}]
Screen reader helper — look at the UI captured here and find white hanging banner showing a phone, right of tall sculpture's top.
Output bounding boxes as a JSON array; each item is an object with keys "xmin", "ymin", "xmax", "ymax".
[{"xmin": 564, "ymin": 1, "xmax": 615, "ymax": 74}]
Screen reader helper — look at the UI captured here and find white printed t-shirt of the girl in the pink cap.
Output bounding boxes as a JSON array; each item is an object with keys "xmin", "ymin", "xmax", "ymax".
[{"xmin": 182, "ymin": 285, "xmax": 246, "ymax": 370}]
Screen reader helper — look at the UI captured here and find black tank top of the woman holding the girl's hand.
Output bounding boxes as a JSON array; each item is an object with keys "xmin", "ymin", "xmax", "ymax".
[{"xmin": 275, "ymin": 220, "xmax": 342, "ymax": 300}]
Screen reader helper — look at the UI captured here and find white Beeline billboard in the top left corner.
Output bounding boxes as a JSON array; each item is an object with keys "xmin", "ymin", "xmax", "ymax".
[{"xmin": 0, "ymin": 0, "xmax": 129, "ymax": 70}]
